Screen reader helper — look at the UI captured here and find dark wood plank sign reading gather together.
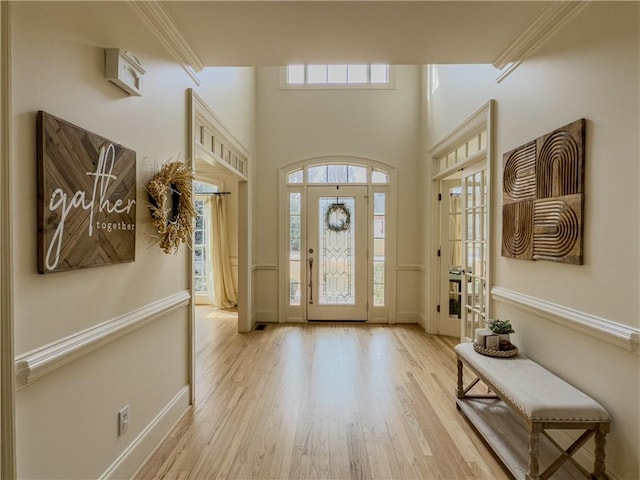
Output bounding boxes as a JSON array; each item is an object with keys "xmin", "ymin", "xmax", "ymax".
[{"xmin": 37, "ymin": 111, "xmax": 136, "ymax": 274}]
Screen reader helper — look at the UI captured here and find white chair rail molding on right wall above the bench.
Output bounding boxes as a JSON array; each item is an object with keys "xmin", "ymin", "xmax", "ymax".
[{"xmin": 491, "ymin": 287, "xmax": 640, "ymax": 355}]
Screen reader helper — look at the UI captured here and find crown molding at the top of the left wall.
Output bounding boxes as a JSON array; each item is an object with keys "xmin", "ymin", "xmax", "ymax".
[{"xmin": 129, "ymin": 0, "xmax": 204, "ymax": 85}]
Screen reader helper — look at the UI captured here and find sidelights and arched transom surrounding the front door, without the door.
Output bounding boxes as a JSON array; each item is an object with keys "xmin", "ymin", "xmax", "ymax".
[{"xmin": 278, "ymin": 156, "xmax": 397, "ymax": 323}]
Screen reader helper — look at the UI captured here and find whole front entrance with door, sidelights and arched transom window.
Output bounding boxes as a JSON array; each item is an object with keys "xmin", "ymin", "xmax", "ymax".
[{"xmin": 278, "ymin": 155, "xmax": 396, "ymax": 323}]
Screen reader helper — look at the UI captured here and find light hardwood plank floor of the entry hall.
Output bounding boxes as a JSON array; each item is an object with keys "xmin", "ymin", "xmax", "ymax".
[{"xmin": 135, "ymin": 307, "xmax": 510, "ymax": 480}]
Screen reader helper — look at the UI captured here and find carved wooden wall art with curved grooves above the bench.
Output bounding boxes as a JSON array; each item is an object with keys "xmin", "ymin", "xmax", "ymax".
[{"xmin": 502, "ymin": 119, "xmax": 586, "ymax": 265}]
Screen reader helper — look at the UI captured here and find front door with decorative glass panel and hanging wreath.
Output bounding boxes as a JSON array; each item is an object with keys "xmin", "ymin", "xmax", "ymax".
[{"xmin": 307, "ymin": 185, "xmax": 368, "ymax": 321}]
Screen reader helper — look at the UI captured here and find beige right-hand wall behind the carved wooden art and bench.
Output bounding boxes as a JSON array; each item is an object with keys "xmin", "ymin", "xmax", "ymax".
[{"xmin": 427, "ymin": 2, "xmax": 640, "ymax": 479}]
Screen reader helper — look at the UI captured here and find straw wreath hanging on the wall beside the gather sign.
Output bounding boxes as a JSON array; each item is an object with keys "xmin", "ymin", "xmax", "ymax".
[{"xmin": 147, "ymin": 161, "xmax": 196, "ymax": 254}]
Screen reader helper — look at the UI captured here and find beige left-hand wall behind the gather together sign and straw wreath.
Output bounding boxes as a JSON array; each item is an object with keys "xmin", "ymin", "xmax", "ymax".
[{"xmin": 12, "ymin": 2, "xmax": 255, "ymax": 478}]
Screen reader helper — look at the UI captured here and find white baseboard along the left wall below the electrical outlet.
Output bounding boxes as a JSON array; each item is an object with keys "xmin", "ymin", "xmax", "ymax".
[{"xmin": 100, "ymin": 385, "xmax": 189, "ymax": 480}]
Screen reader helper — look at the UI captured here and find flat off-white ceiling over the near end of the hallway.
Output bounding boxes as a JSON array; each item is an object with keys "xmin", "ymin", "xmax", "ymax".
[{"xmin": 161, "ymin": 0, "xmax": 550, "ymax": 66}]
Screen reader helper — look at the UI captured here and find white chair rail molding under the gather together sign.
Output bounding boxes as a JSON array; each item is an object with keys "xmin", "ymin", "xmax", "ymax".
[{"xmin": 15, "ymin": 290, "xmax": 191, "ymax": 388}]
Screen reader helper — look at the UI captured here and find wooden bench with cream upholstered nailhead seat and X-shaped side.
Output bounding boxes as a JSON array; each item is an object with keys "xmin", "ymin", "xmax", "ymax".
[{"xmin": 455, "ymin": 343, "xmax": 611, "ymax": 480}]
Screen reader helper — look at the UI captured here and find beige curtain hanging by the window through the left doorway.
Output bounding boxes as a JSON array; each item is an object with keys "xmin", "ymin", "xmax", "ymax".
[{"xmin": 209, "ymin": 195, "xmax": 238, "ymax": 308}]
